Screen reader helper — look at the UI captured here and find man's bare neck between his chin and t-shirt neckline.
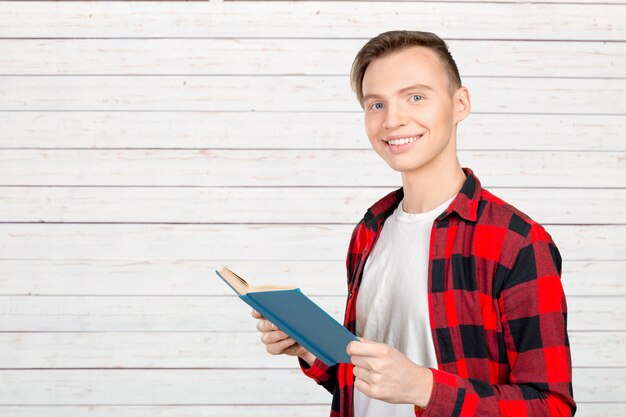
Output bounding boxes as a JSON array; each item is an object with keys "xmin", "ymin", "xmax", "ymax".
[{"xmin": 402, "ymin": 155, "xmax": 466, "ymax": 213}]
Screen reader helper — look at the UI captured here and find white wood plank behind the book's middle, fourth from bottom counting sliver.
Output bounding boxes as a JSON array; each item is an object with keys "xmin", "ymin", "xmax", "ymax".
[{"xmin": 0, "ymin": 294, "xmax": 626, "ymax": 332}]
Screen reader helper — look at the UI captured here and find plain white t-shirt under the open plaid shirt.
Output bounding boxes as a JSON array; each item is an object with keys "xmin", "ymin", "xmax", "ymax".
[{"xmin": 354, "ymin": 197, "xmax": 454, "ymax": 417}]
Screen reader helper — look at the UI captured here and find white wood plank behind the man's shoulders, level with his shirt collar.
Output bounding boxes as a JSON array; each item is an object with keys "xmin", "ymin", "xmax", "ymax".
[{"xmin": 0, "ymin": 187, "xmax": 626, "ymax": 224}]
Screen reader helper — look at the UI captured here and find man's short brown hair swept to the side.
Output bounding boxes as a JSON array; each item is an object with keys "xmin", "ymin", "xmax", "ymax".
[{"xmin": 350, "ymin": 30, "xmax": 462, "ymax": 107}]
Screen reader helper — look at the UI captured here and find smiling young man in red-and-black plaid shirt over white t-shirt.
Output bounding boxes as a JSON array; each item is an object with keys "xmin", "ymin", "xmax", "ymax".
[{"xmin": 253, "ymin": 31, "xmax": 576, "ymax": 417}]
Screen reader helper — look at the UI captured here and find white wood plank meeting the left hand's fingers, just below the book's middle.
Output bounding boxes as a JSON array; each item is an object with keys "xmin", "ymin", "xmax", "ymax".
[{"xmin": 0, "ymin": 331, "xmax": 626, "ymax": 369}]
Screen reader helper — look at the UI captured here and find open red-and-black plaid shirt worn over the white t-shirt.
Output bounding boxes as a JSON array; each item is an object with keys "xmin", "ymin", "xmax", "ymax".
[{"xmin": 300, "ymin": 168, "xmax": 576, "ymax": 417}]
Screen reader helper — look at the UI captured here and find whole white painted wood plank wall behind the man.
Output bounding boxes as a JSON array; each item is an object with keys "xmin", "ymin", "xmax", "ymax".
[{"xmin": 0, "ymin": 0, "xmax": 626, "ymax": 417}]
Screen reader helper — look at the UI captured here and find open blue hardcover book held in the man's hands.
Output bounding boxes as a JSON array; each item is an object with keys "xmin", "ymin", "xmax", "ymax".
[{"xmin": 215, "ymin": 267, "xmax": 358, "ymax": 366}]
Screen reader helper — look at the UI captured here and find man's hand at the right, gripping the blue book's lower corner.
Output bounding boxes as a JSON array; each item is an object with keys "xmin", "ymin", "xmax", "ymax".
[{"xmin": 347, "ymin": 338, "xmax": 433, "ymax": 408}]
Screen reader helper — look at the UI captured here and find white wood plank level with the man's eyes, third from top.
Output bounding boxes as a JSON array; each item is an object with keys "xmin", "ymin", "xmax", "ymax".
[{"xmin": 0, "ymin": 75, "xmax": 626, "ymax": 115}]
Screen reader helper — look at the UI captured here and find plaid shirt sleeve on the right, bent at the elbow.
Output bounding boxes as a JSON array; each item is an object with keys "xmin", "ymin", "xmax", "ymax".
[{"xmin": 415, "ymin": 223, "xmax": 576, "ymax": 417}]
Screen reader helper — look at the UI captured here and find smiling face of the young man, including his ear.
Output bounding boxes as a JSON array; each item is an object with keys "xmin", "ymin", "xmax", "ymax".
[{"xmin": 363, "ymin": 46, "xmax": 469, "ymax": 173}]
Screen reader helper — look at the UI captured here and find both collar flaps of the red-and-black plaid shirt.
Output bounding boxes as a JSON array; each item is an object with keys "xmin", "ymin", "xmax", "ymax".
[{"xmin": 364, "ymin": 168, "xmax": 482, "ymax": 231}]
